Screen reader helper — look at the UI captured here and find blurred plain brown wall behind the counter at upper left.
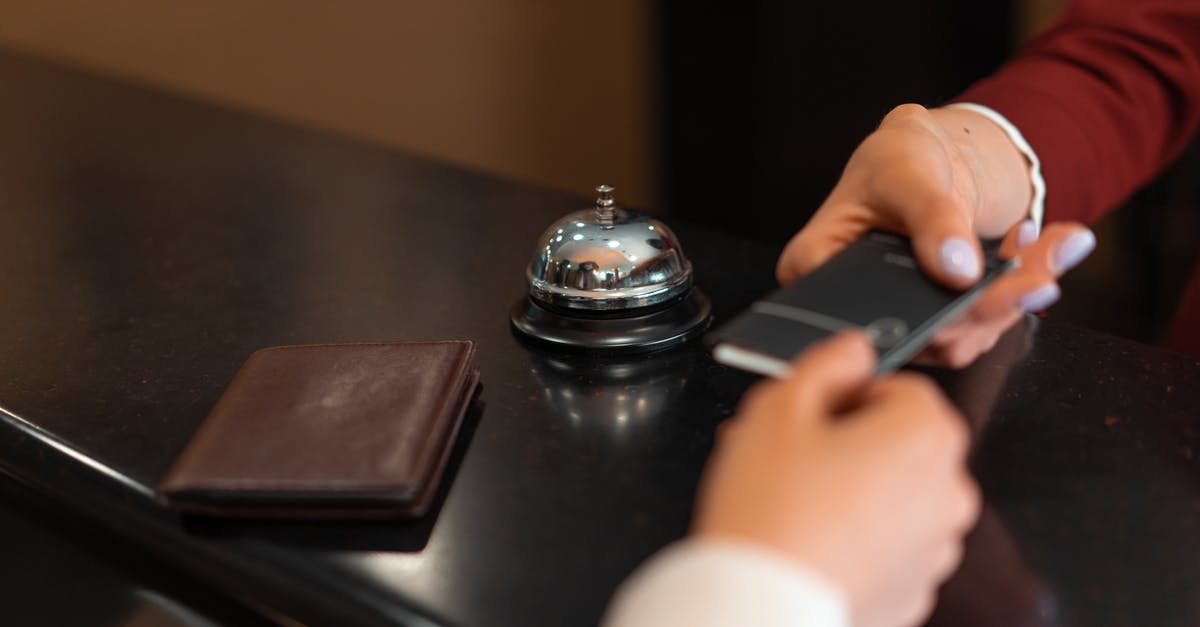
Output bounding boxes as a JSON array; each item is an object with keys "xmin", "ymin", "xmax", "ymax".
[{"xmin": 0, "ymin": 0, "xmax": 659, "ymax": 207}]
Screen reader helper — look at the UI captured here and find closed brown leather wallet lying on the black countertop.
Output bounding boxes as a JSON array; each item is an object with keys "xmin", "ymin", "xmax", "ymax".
[{"xmin": 158, "ymin": 341, "xmax": 479, "ymax": 518}]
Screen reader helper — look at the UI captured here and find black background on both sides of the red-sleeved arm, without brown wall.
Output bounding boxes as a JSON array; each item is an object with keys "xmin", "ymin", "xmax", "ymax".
[{"xmin": 659, "ymin": 0, "xmax": 1200, "ymax": 342}]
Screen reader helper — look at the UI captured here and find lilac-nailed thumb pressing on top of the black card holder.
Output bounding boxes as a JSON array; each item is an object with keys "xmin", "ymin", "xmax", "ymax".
[{"xmin": 901, "ymin": 196, "xmax": 983, "ymax": 289}]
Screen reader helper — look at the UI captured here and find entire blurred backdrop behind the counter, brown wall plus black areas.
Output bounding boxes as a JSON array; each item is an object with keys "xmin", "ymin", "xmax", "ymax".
[{"xmin": 0, "ymin": 0, "xmax": 1200, "ymax": 341}]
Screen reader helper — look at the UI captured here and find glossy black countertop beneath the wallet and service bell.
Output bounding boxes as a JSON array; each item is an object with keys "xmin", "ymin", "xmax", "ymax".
[{"xmin": 0, "ymin": 47, "xmax": 1200, "ymax": 627}]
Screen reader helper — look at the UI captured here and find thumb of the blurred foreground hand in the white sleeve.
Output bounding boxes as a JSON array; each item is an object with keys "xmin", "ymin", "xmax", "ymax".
[{"xmin": 782, "ymin": 330, "xmax": 876, "ymax": 417}]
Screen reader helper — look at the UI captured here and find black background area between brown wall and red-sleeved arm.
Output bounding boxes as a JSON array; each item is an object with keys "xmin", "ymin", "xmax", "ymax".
[{"xmin": 659, "ymin": 0, "xmax": 1016, "ymax": 244}]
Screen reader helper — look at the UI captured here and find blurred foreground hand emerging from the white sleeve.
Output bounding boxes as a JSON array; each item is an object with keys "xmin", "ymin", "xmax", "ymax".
[{"xmin": 694, "ymin": 333, "xmax": 979, "ymax": 627}]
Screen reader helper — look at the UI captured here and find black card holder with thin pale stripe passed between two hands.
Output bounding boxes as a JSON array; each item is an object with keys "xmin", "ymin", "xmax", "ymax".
[{"xmin": 707, "ymin": 231, "xmax": 1015, "ymax": 376}]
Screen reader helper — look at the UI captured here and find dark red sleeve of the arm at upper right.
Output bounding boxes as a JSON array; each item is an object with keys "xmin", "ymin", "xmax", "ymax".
[{"xmin": 955, "ymin": 0, "xmax": 1200, "ymax": 221}]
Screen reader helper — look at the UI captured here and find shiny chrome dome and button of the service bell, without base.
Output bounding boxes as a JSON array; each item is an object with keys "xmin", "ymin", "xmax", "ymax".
[{"xmin": 526, "ymin": 185, "xmax": 691, "ymax": 311}]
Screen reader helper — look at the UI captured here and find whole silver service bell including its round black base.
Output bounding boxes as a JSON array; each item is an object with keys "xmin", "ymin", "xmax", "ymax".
[{"xmin": 511, "ymin": 185, "xmax": 712, "ymax": 351}]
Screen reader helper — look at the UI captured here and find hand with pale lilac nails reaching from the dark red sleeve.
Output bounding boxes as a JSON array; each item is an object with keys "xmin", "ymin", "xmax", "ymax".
[{"xmin": 776, "ymin": 105, "xmax": 1096, "ymax": 368}]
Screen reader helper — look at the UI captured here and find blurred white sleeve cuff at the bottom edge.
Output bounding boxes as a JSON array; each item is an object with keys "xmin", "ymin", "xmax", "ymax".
[{"xmin": 604, "ymin": 539, "xmax": 850, "ymax": 627}]
